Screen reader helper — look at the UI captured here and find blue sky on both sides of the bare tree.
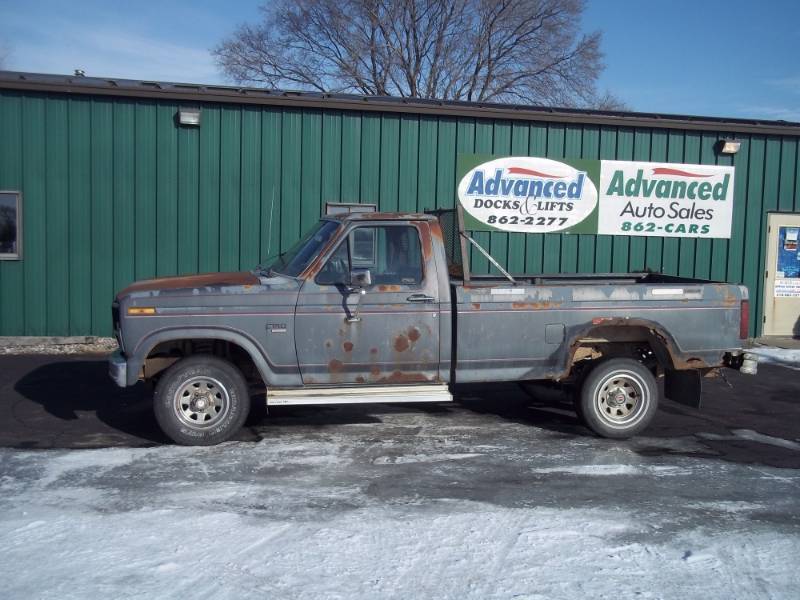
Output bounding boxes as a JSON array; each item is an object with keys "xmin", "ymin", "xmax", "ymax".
[{"xmin": 0, "ymin": 0, "xmax": 800, "ymax": 121}]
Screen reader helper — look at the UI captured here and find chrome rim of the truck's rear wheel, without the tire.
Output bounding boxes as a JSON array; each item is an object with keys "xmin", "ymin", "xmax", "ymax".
[{"xmin": 594, "ymin": 371, "xmax": 650, "ymax": 428}]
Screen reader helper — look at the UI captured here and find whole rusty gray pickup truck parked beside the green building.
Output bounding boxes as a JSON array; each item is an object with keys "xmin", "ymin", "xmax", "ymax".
[{"xmin": 110, "ymin": 210, "xmax": 756, "ymax": 445}]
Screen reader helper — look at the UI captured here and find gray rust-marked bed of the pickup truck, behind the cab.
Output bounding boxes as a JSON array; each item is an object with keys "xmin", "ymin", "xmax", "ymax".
[{"xmin": 451, "ymin": 273, "xmax": 747, "ymax": 382}]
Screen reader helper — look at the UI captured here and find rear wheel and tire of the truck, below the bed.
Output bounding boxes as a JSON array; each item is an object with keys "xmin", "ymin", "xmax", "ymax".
[{"xmin": 576, "ymin": 358, "xmax": 659, "ymax": 439}]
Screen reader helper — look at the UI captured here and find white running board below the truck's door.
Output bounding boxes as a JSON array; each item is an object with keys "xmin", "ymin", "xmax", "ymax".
[{"xmin": 267, "ymin": 385, "xmax": 453, "ymax": 406}]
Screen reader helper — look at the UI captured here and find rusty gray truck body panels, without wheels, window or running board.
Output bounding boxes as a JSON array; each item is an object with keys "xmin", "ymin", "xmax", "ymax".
[{"xmin": 110, "ymin": 213, "xmax": 747, "ymax": 388}]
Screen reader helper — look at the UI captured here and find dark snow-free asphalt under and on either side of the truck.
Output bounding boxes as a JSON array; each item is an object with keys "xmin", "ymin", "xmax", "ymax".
[{"xmin": 0, "ymin": 355, "xmax": 800, "ymax": 469}]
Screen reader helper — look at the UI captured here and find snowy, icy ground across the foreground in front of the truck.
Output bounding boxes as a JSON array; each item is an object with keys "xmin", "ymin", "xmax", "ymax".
[{"xmin": 0, "ymin": 407, "xmax": 800, "ymax": 600}]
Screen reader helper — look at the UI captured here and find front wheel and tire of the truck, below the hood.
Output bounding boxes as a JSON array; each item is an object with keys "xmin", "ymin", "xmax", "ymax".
[{"xmin": 153, "ymin": 355, "xmax": 250, "ymax": 446}]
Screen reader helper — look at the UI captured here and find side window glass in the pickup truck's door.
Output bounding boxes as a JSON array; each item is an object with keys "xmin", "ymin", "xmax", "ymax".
[{"xmin": 317, "ymin": 225, "xmax": 422, "ymax": 285}]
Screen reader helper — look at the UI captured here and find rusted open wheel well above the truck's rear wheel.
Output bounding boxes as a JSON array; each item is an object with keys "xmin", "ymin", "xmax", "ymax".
[{"xmin": 568, "ymin": 325, "xmax": 673, "ymax": 376}]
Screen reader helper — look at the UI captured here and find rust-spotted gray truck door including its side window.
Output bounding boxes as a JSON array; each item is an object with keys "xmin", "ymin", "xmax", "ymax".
[{"xmin": 295, "ymin": 222, "xmax": 440, "ymax": 385}]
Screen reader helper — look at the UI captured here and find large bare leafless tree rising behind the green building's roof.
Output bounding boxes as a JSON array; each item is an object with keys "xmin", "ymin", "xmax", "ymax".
[{"xmin": 213, "ymin": 0, "xmax": 622, "ymax": 109}]
